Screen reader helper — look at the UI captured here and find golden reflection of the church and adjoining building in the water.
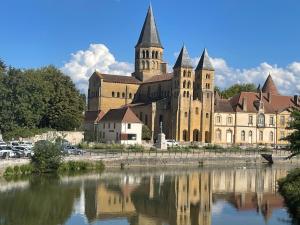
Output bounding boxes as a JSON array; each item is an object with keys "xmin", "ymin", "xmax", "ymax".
[{"xmin": 85, "ymin": 169, "xmax": 286, "ymax": 225}]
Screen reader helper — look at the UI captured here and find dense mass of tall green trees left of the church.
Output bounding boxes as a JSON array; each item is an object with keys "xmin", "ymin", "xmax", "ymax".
[{"xmin": 0, "ymin": 60, "xmax": 85, "ymax": 139}]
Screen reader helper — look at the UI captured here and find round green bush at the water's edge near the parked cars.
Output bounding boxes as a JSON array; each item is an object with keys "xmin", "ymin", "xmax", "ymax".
[{"xmin": 31, "ymin": 141, "xmax": 62, "ymax": 173}]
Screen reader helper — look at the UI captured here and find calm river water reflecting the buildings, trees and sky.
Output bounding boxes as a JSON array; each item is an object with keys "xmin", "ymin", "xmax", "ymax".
[{"xmin": 0, "ymin": 166, "xmax": 296, "ymax": 225}]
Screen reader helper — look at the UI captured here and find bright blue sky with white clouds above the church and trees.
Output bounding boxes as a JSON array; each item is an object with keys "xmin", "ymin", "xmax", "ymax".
[{"xmin": 0, "ymin": 0, "xmax": 300, "ymax": 95}]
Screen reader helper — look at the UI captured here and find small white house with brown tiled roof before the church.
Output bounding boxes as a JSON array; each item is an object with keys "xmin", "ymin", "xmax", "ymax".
[{"xmin": 97, "ymin": 107, "xmax": 143, "ymax": 144}]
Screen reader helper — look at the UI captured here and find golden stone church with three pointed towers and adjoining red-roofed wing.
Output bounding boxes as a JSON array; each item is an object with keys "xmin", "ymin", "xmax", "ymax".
[{"xmin": 84, "ymin": 6, "xmax": 300, "ymax": 146}]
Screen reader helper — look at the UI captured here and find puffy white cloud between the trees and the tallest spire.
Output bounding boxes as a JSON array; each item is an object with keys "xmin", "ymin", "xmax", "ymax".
[{"xmin": 61, "ymin": 44, "xmax": 133, "ymax": 93}]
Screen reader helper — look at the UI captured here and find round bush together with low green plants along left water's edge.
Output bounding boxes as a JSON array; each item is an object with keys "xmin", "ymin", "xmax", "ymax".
[{"xmin": 4, "ymin": 141, "xmax": 105, "ymax": 177}]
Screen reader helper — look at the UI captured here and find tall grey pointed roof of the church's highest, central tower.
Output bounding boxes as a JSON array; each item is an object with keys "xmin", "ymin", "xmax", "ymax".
[{"xmin": 136, "ymin": 5, "xmax": 162, "ymax": 48}]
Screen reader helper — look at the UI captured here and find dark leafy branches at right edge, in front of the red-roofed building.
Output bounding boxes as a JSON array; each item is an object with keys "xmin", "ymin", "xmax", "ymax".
[{"xmin": 284, "ymin": 109, "xmax": 300, "ymax": 159}]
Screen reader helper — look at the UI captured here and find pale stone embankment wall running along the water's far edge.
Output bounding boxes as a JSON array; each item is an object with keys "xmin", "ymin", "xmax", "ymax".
[{"xmin": 0, "ymin": 151, "xmax": 300, "ymax": 174}]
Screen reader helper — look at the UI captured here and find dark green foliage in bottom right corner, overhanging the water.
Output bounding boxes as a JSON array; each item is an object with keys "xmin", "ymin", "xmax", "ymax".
[{"xmin": 278, "ymin": 168, "xmax": 300, "ymax": 224}]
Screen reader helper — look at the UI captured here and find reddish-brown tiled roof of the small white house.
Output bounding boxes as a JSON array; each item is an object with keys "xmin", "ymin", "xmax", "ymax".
[{"xmin": 100, "ymin": 106, "xmax": 142, "ymax": 123}]
